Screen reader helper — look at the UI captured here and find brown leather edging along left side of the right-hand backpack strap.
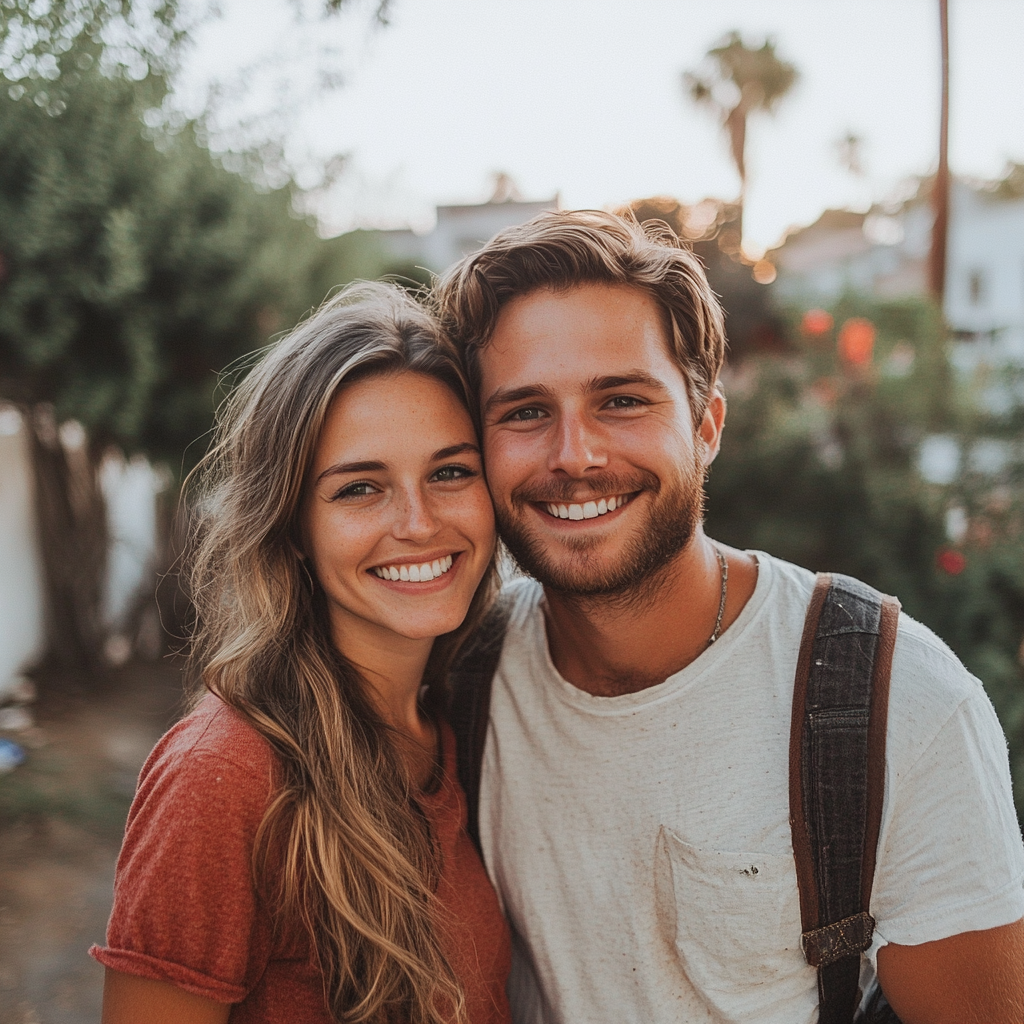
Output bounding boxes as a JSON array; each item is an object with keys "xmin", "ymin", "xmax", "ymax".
[{"xmin": 790, "ymin": 572, "xmax": 831, "ymax": 932}]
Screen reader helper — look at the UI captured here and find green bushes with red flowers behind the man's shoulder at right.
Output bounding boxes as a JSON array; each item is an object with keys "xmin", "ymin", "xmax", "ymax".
[{"xmin": 708, "ymin": 297, "xmax": 1024, "ymax": 820}]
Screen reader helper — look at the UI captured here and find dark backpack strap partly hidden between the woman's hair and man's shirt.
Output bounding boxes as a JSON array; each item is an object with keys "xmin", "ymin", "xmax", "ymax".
[{"xmin": 449, "ymin": 594, "xmax": 511, "ymax": 856}]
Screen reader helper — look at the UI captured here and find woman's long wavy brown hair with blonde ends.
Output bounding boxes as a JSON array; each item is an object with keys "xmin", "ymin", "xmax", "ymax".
[{"xmin": 186, "ymin": 284, "xmax": 495, "ymax": 1024}]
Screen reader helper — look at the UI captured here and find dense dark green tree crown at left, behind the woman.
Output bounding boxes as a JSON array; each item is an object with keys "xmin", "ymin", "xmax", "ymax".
[{"xmin": 0, "ymin": 44, "xmax": 376, "ymax": 468}]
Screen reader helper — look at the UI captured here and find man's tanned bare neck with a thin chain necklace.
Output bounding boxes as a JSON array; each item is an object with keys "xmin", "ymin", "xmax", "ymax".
[{"xmin": 544, "ymin": 527, "xmax": 757, "ymax": 696}]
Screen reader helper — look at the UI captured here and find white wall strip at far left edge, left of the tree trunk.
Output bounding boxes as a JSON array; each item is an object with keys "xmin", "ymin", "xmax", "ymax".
[{"xmin": 0, "ymin": 406, "xmax": 43, "ymax": 695}]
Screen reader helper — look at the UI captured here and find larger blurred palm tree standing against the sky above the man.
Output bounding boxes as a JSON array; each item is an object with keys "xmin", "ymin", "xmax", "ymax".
[{"xmin": 683, "ymin": 32, "xmax": 799, "ymax": 237}]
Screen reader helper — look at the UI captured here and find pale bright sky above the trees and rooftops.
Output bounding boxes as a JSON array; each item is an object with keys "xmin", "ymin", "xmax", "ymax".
[{"xmin": 178, "ymin": 0, "xmax": 1024, "ymax": 253}]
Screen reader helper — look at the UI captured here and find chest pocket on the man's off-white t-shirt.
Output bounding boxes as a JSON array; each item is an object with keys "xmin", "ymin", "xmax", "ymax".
[{"xmin": 657, "ymin": 826, "xmax": 817, "ymax": 1022}]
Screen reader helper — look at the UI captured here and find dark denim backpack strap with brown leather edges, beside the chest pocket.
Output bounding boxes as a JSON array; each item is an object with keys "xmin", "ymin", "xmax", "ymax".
[{"xmin": 790, "ymin": 573, "xmax": 900, "ymax": 1024}]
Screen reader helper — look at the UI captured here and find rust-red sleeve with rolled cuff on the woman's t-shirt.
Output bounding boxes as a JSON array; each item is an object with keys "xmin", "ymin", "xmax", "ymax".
[{"xmin": 90, "ymin": 750, "xmax": 270, "ymax": 1002}]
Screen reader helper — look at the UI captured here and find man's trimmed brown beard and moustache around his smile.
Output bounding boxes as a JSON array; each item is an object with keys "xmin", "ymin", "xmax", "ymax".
[{"xmin": 495, "ymin": 452, "xmax": 705, "ymax": 601}]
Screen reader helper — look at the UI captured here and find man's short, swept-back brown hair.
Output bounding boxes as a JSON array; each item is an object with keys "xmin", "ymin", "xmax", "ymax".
[{"xmin": 434, "ymin": 210, "xmax": 725, "ymax": 424}]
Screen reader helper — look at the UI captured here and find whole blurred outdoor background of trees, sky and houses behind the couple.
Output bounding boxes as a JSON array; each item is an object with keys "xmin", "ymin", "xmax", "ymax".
[{"xmin": 0, "ymin": 0, "xmax": 1024, "ymax": 1024}]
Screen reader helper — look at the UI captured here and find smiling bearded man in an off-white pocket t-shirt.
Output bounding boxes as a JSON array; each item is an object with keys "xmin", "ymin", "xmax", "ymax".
[{"xmin": 438, "ymin": 212, "xmax": 1024, "ymax": 1024}]
